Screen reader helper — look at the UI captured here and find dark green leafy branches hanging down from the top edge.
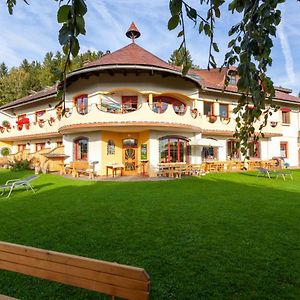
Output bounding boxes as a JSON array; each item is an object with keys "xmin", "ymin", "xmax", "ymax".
[{"xmin": 7, "ymin": 0, "xmax": 299, "ymax": 154}]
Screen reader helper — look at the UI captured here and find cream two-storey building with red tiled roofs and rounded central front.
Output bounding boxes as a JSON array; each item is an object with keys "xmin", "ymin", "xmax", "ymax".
[{"xmin": 0, "ymin": 26, "xmax": 300, "ymax": 175}]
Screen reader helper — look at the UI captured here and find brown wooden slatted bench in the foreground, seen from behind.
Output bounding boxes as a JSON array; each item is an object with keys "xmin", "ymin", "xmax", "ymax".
[{"xmin": 0, "ymin": 242, "xmax": 150, "ymax": 300}]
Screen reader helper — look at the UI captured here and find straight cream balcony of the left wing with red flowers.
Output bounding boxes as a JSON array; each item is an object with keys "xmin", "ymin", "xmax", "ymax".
[{"xmin": 0, "ymin": 117, "xmax": 60, "ymax": 141}]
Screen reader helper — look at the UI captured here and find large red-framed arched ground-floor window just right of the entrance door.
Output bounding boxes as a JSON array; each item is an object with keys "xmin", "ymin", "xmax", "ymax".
[{"xmin": 159, "ymin": 137, "xmax": 191, "ymax": 163}]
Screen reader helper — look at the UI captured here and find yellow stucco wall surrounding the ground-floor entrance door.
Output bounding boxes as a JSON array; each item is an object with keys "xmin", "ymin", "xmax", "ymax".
[{"xmin": 100, "ymin": 130, "xmax": 150, "ymax": 175}]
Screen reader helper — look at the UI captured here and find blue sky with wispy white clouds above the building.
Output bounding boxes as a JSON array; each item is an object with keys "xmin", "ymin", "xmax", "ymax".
[{"xmin": 0, "ymin": 0, "xmax": 300, "ymax": 95}]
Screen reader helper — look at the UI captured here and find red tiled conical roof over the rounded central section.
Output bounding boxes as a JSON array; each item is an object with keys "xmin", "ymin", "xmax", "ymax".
[{"xmin": 83, "ymin": 43, "xmax": 178, "ymax": 71}]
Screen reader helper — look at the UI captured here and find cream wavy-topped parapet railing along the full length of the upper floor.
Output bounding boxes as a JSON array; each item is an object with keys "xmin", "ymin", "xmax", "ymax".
[{"xmin": 0, "ymin": 102, "xmax": 282, "ymax": 141}]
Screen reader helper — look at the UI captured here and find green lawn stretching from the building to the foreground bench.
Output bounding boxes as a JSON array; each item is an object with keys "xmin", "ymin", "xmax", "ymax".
[{"xmin": 0, "ymin": 171, "xmax": 300, "ymax": 299}]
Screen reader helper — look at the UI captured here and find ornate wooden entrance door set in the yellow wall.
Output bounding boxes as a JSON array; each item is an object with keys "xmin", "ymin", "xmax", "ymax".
[{"xmin": 123, "ymin": 139, "xmax": 138, "ymax": 175}]
